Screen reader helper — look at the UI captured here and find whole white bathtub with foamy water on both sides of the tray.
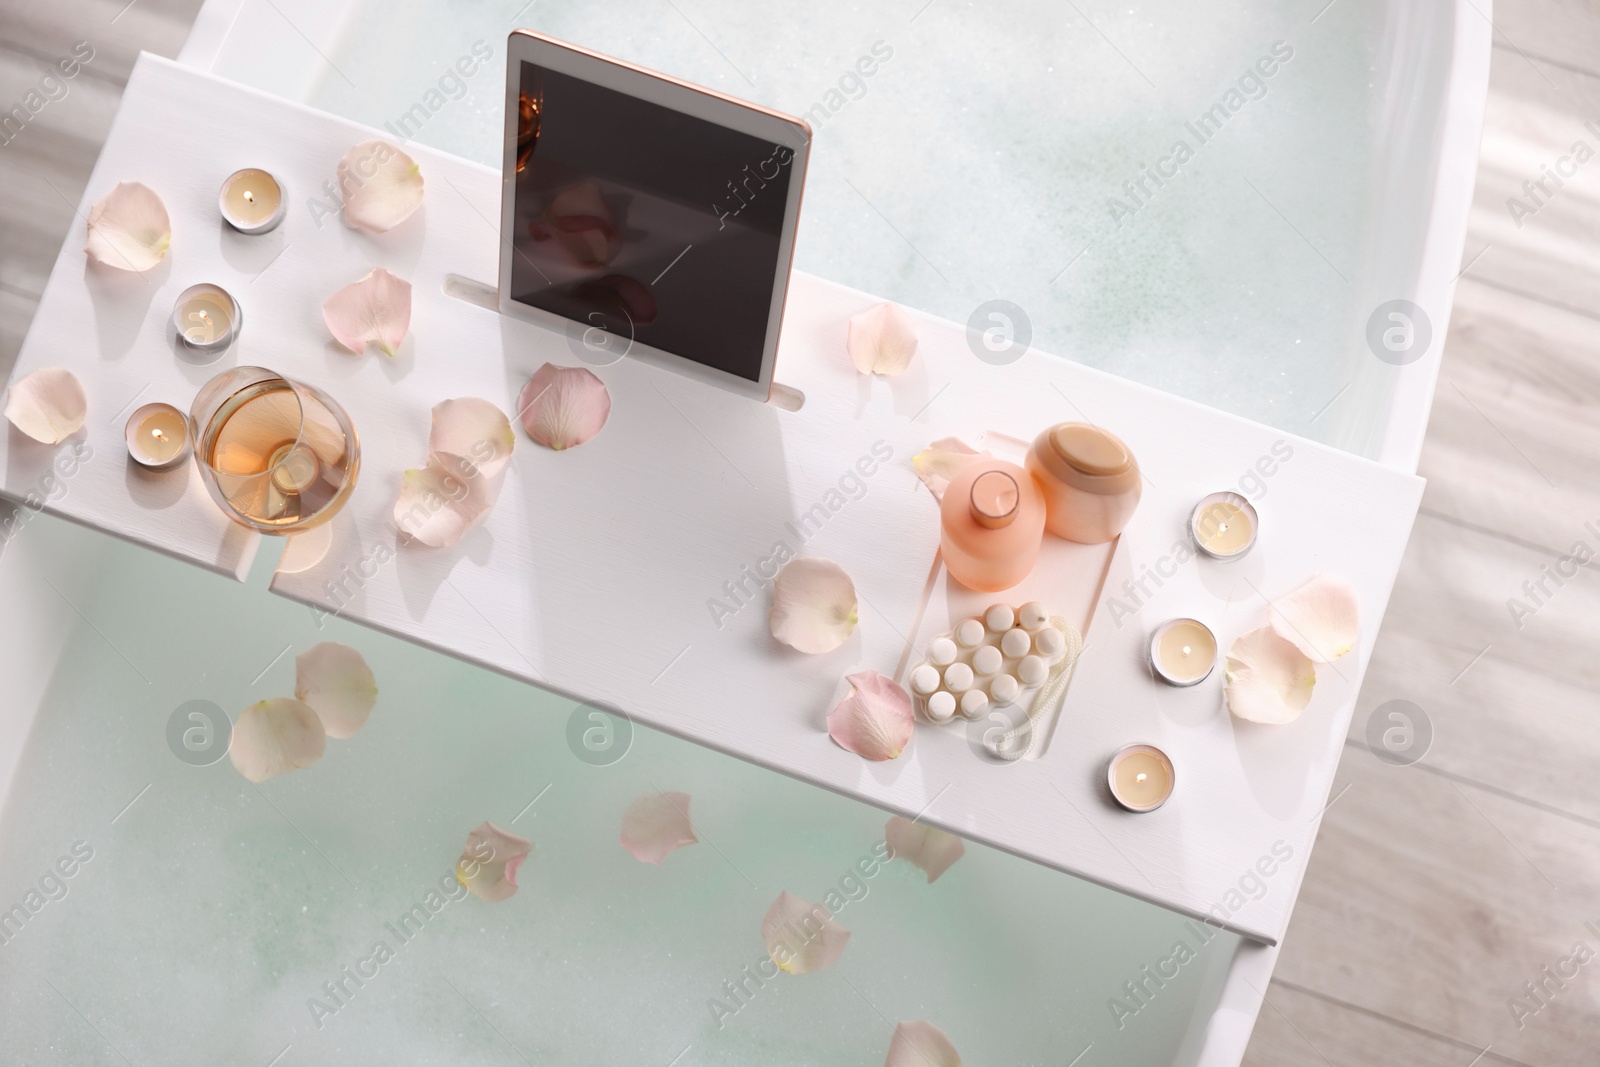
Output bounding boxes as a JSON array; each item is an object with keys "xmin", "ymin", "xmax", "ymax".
[{"xmin": 0, "ymin": 0, "xmax": 1490, "ymax": 1067}]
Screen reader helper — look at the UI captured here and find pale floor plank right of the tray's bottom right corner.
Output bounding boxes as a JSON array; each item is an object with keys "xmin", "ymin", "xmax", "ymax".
[{"xmin": 1277, "ymin": 747, "xmax": 1600, "ymax": 1064}]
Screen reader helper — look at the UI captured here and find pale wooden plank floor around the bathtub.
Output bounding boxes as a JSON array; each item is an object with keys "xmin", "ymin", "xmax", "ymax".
[{"xmin": 0, "ymin": 0, "xmax": 1600, "ymax": 1067}]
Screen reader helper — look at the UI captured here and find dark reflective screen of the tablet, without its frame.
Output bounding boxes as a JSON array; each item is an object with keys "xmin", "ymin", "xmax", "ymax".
[{"xmin": 510, "ymin": 62, "xmax": 794, "ymax": 382}]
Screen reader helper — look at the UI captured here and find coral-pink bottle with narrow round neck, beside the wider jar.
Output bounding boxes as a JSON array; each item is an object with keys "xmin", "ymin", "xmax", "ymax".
[{"xmin": 939, "ymin": 458, "xmax": 1045, "ymax": 593}]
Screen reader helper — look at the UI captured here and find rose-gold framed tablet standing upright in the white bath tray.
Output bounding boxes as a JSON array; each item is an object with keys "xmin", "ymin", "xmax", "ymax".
[{"xmin": 499, "ymin": 30, "xmax": 811, "ymax": 400}]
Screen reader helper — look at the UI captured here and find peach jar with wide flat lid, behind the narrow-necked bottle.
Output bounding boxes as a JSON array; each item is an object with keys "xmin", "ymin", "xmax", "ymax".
[{"xmin": 1027, "ymin": 422, "xmax": 1141, "ymax": 544}]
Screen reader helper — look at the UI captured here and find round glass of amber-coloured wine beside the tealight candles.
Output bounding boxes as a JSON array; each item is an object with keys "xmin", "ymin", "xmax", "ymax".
[{"xmin": 189, "ymin": 366, "xmax": 362, "ymax": 534}]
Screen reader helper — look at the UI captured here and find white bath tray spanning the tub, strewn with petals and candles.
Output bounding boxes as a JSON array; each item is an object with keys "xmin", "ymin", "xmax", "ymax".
[{"xmin": 0, "ymin": 56, "xmax": 1422, "ymax": 941}]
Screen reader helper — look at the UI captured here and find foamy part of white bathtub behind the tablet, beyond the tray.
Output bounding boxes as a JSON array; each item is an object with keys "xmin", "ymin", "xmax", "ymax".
[{"xmin": 181, "ymin": 0, "xmax": 1491, "ymax": 470}]
